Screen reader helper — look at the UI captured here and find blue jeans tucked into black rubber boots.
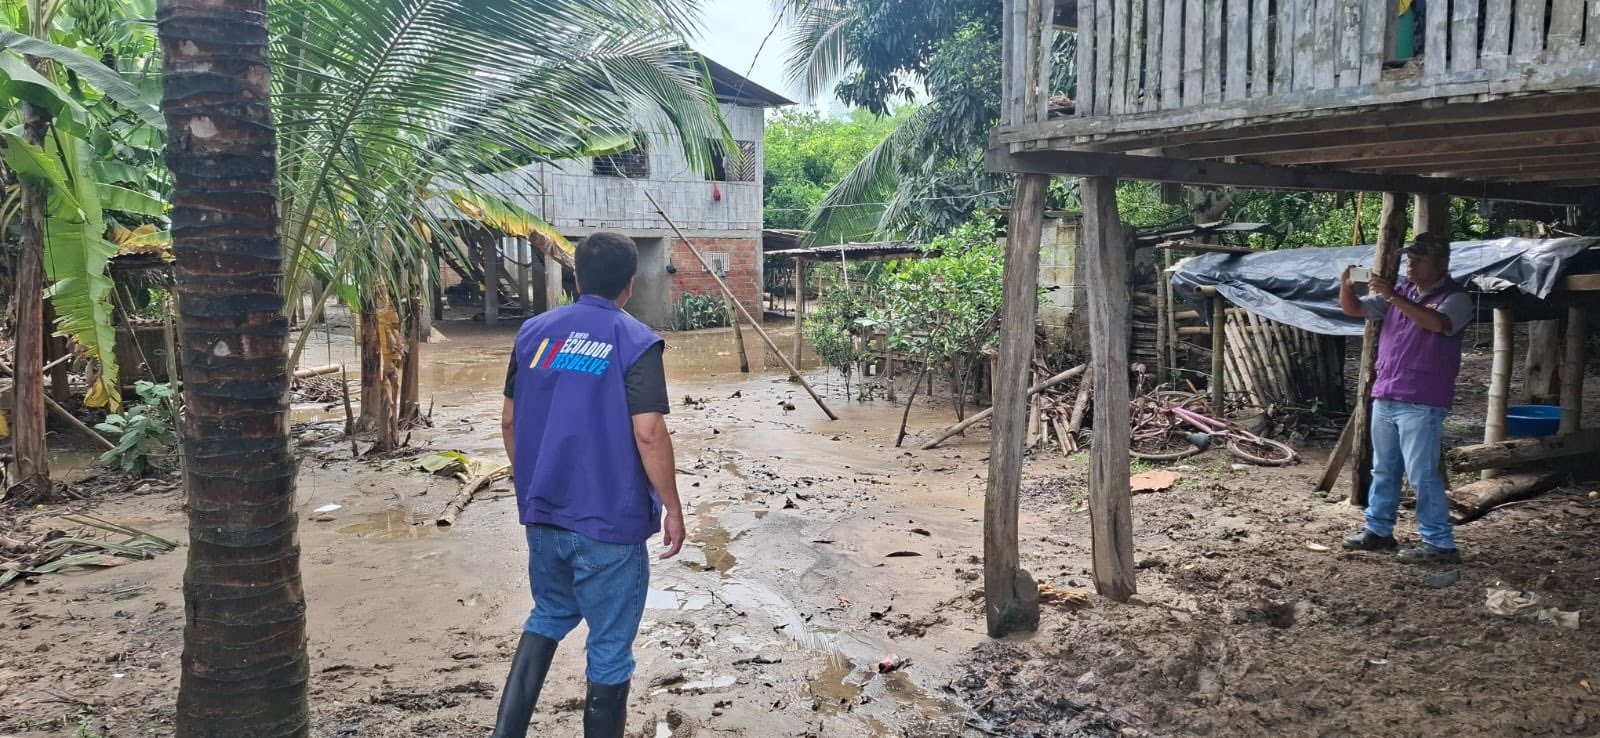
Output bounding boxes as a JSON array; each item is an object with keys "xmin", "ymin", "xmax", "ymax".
[{"xmin": 522, "ymin": 525, "xmax": 650, "ymax": 685}]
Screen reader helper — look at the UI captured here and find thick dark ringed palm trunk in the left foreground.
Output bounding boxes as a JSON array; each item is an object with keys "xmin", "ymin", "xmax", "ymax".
[{"xmin": 157, "ymin": 0, "xmax": 309, "ymax": 738}]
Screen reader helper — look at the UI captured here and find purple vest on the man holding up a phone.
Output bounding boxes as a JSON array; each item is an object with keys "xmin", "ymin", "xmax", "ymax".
[{"xmin": 1373, "ymin": 277, "xmax": 1466, "ymax": 410}]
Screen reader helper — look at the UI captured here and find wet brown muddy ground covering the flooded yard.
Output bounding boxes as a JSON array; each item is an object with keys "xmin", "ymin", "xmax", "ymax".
[{"xmin": 0, "ymin": 325, "xmax": 1600, "ymax": 736}]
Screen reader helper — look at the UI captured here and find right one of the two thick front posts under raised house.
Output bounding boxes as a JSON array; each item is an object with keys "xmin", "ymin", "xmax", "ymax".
[{"xmin": 1080, "ymin": 178, "xmax": 1139, "ymax": 602}]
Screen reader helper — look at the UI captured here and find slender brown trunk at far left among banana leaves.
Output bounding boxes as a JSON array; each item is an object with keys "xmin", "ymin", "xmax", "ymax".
[{"xmin": 11, "ymin": 90, "xmax": 51, "ymax": 504}]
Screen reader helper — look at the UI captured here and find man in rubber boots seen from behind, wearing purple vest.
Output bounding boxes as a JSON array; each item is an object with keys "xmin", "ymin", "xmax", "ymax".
[{"xmin": 494, "ymin": 234, "xmax": 683, "ymax": 738}]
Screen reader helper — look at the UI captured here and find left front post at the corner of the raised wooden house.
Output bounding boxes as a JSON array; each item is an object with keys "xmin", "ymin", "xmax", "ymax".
[{"xmin": 984, "ymin": 174, "xmax": 1050, "ymax": 637}]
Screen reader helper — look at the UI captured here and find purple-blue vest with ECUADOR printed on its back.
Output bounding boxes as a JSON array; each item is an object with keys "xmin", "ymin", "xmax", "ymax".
[{"xmin": 512, "ymin": 295, "xmax": 661, "ymax": 544}]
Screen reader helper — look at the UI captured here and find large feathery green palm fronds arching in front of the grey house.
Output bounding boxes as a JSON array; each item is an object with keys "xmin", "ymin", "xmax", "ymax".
[{"xmin": 272, "ymin": 0, "xmax": 731, "ymax": 326}]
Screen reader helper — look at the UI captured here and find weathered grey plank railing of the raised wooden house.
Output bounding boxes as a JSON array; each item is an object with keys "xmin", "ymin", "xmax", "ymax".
[{"xmin": 1075, "ymin": 0, "xmax": 1600, "ymax": 115}]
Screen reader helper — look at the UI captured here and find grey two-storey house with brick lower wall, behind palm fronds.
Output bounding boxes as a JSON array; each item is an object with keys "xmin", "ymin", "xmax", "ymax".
[{"xmin": 480, "ymin": 59, "xmax": 794, "ymax": 328}]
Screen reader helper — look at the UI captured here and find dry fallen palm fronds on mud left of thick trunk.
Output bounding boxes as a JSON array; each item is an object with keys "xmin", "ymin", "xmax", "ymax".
[{"xmin": 0, "ymin": 515, "xmax": 178, "ymax": 589}]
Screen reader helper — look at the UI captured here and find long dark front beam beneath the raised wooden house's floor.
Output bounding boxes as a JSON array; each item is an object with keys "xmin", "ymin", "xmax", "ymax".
[{"xmin": 987, "ymin": 147, "xmax": 1584, "ymax": 205}]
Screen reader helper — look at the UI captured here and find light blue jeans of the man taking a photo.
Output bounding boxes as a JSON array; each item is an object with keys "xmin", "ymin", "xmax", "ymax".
[{"xmin": 1366, "ymin": 400, "xmax": 1456, "ymax": 549}]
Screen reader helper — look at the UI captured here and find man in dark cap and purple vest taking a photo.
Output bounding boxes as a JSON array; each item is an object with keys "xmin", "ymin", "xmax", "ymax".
[{"xmin": 1339, "ymin": 234, "xmax": 1475, "ymax": 564}]
